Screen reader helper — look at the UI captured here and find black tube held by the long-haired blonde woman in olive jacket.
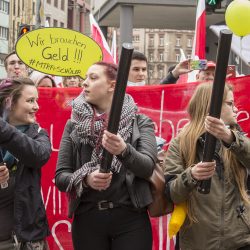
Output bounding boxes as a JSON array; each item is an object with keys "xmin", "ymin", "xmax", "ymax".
[{"xmin": 198, "ymin": 29, "xmax": 232, "ymax": 194}]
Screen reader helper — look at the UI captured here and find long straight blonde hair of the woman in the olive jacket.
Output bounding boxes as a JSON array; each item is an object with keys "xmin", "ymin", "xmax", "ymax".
[{"xmin": 178, "ymin": 83, "xmax": 249, "ymax": 222}]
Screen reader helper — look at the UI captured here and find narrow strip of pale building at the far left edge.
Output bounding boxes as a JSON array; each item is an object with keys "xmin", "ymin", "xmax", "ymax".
[{"xmin": 0, "ymin": 0, "xmax": 10, "ymax": 78}]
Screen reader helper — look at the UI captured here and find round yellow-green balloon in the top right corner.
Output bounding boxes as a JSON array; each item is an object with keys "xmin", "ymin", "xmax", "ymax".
[{"xmin": 225, "ymin": 0, "xmax": 250, "ymax": 36}]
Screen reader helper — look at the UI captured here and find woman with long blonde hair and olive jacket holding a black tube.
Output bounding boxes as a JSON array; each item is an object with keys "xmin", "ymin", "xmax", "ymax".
[{"xmin": 164, "ymin": 83, "xmax": 250, "ymax": 250}]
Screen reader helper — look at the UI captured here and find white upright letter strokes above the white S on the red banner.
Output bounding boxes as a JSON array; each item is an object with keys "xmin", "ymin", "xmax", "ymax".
[{"xmin": 41, "ymin": 179, "xmax": 62, "ymax": 215}]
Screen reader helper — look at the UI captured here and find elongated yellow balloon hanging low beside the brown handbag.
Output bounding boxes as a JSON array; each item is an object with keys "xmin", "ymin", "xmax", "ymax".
[{"xmin": 168, "ymin": 202, "xmax": 187, "ymax": 239}]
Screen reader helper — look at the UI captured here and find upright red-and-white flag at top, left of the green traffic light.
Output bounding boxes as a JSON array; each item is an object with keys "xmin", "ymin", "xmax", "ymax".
[{"xmin": 192, "ymin": 0, "xmax": 206, "ymax": 59}]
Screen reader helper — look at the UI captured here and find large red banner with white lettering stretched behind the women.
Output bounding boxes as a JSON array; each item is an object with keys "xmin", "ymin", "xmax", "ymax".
[{"xmin": 37, "ymin": 76, "xmax": 250, "ymax": 250}]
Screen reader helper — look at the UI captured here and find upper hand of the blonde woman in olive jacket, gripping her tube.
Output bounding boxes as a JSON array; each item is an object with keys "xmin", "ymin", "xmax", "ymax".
[{"xmin": 205, "ymin": 116, "xmax": 234, "ymax": 144}]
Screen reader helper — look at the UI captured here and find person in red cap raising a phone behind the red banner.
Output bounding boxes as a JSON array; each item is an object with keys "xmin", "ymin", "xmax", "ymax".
[{"xmin": 160, "ymin": 59, "xmax": 216, "ymax": 84}]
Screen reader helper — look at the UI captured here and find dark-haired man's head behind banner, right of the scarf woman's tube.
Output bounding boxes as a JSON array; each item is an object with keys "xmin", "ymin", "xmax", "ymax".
[{"xmin": 127, "ymin": 51, "xmax": 148, "ymax": 86}]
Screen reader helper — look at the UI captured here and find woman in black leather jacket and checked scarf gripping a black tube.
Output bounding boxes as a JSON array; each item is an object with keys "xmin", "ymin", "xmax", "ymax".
[{"xmin": 55, "ymin": 62, "xmax": 157, "ymax": 250}]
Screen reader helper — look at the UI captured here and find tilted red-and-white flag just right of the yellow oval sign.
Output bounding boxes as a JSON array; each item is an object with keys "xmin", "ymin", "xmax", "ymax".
[{"xmin": 89, "ymin": 13, "xmax": 114, "ymax": 63}]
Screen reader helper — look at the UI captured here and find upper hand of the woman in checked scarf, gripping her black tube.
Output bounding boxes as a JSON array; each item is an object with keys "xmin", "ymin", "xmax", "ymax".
[{"xmin": 102, "ymin": 130, "xmax": 126, "ymax": 155}]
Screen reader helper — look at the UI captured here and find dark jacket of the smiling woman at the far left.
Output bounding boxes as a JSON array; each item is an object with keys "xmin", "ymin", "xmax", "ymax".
[{"xmin": 0, "ymin": 118, "xmax": 51, "ymax": 242}]
